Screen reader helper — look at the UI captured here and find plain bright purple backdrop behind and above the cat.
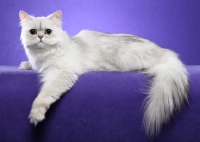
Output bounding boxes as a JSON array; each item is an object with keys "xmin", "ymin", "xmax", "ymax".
[{"xmin": 0, "ymin": 0, "xmax": 200, "ymax": 65}]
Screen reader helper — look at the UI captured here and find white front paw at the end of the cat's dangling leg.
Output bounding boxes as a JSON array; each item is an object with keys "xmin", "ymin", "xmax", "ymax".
[{"xmin": 29, "ymin": 107, "xmax": 46, "ymax": 126}]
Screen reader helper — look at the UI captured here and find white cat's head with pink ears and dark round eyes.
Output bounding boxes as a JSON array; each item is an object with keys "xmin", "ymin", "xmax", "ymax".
[{"xmin": 19, "ymin": 11, "xmax": 63, "ymax": 49}]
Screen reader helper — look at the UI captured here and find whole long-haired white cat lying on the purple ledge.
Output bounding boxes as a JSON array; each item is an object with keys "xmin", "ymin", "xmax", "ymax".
[{"xmin": 19, "ymin": 11, "xmax": 189, "ymax": 136}]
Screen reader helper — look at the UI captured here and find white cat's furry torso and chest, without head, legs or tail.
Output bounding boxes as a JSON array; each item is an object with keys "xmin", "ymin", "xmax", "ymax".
[{"xmin": 26, "ymin": 30, "xmax": 162, "ymax": 74}]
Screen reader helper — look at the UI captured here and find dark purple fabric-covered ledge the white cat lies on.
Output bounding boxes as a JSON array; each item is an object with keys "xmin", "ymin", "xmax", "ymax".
[{"xmin": 0, "ymin": 66, "xmax": 200, "ymax": 142}]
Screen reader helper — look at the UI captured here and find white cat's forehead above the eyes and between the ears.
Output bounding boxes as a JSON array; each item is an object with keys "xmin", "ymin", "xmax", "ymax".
[{"xmin": 28, "ymin": 17, "xmax": 54, "ymax": 30}]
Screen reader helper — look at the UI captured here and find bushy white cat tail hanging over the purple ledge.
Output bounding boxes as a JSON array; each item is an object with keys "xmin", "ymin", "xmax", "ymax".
[{"xmin": 144, "ymin": 51, "xmax": 188, "ymax": 136}]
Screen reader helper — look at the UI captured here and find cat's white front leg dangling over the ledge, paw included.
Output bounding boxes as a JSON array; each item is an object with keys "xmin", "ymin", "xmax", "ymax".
[{"xmin": 29, "ymin": 69, "xmax": 78, "ymax": 125}]
